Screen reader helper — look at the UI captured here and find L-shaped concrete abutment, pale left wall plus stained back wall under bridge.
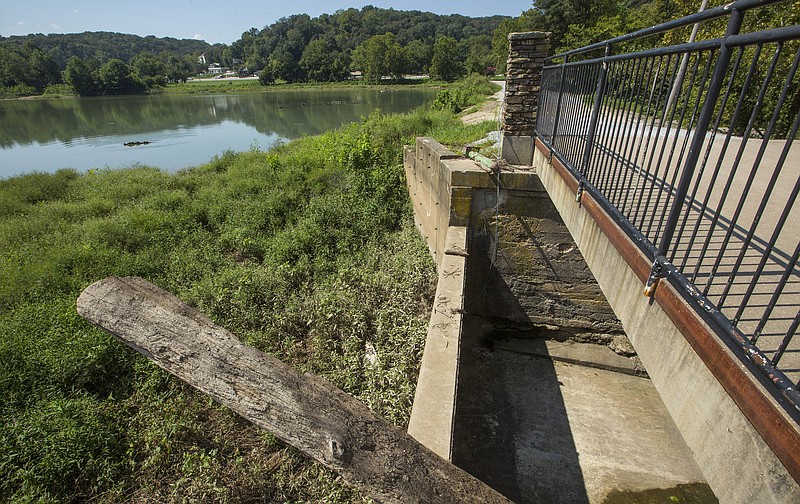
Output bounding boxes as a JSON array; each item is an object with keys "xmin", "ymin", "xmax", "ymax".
[{"xmin": 404, "ymin": 138, "xmax": 633, "ymax": 459}]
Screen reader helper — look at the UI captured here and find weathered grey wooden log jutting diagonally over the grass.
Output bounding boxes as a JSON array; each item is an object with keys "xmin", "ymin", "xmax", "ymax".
[{"xmin": 78, "ymin": 277, "xmax": 509, "ymax": 503}]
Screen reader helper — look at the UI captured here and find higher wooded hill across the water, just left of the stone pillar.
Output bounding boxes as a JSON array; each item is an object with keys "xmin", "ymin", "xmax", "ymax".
[{"xmin": 230, "ymin": 6, "xmax": 511, "ymax": 84}]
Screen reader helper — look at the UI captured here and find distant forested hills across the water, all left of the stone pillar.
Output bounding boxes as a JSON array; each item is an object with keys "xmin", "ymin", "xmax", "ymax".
[{"xmin": 0, "ymin": 6, "xmax": 510, "ymax": 96}]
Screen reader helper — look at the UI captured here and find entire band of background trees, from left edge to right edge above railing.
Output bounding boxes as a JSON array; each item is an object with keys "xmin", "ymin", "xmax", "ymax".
[{"xmin": 0, "ymin": 0, "xmax": 800, "ymax": 95}]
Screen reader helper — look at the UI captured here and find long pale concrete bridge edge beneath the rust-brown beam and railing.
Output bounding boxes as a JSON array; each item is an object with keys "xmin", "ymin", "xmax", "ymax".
[{"xmin": 534, "ymin": 139, "xmax": 800, "ymax": 504}]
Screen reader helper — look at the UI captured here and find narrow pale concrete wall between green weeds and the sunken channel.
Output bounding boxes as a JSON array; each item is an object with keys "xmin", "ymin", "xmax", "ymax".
[{"xmin": 403, "ymin": 138, "xmax": 490, "ymax": 460}]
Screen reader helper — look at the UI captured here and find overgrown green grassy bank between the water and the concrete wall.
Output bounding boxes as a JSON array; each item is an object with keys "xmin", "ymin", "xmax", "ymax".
[{"xmin": 0, "ymin": 79, "xmax": 494, "ymax": 502}]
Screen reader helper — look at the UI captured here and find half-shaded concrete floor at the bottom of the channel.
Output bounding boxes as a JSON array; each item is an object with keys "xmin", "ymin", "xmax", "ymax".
[{"xmin": 453, "ymin": 317, "xmax": 717, "ymax": 504}]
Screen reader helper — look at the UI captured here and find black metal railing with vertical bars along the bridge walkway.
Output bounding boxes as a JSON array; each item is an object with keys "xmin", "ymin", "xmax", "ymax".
[{"xmin": 536, "ymin": 0, "xmax": 800, "ymax": 413}]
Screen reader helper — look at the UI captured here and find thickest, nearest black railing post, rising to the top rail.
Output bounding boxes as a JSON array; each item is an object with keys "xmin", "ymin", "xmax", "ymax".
[{"xmin": 644, "ymin": 10, "xmax": 743, "ymax": 296}]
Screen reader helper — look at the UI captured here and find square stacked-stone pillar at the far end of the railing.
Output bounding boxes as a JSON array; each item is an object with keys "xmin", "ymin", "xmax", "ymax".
[{"xmin": 501, "ymin": 32, "xmax": 550, "ymax": 165}]
